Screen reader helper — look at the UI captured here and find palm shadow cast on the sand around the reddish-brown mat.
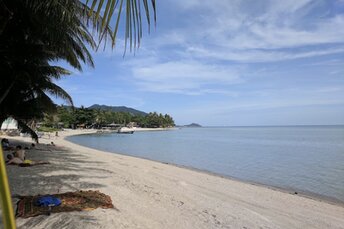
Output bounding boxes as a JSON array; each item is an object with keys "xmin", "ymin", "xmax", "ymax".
[{"xmin": 0, "ymin": 139, "xmax": 113, "ymax": 228}]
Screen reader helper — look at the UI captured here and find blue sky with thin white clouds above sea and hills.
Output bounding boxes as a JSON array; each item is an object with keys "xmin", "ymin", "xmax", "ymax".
[{"xmin": 53, "ymin": 0, "xmax": 344, "ymax": 126}]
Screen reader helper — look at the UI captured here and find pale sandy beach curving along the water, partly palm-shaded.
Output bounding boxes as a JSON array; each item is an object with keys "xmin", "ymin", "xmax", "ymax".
[{"xmin": 2, "ymin": 130, "xmax": 344, "ymax": 229}]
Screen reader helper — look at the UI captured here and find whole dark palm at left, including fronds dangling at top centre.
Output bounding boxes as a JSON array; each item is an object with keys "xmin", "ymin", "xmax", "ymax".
[{"xmin": 0, "ymin": 0, "xmax": 155, "ymax": 140}]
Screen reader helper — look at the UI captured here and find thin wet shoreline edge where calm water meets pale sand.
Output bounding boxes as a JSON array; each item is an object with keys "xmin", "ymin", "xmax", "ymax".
[{"xmin": 63, "ymin": 128, "xmax": 344, "ymax": 207}]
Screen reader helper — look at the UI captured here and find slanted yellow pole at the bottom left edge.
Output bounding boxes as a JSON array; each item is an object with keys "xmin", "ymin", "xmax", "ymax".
[{"xmin": 0, "ymin": 146, "xmax": 16, "ymax": 229}]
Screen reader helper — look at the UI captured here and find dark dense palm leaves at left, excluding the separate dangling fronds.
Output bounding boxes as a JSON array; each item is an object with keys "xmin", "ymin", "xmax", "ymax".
[{"xmin": 0, "ymin": 0, "xmax": 95, "ymax": 139}]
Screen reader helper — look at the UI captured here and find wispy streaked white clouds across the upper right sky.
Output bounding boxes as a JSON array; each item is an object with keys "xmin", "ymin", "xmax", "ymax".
[{"xmin": 152, "ymin": 0, "xmax": 344, "ymax": 62}]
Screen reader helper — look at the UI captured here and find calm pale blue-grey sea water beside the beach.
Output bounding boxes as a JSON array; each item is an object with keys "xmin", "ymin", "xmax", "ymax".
[{"xmin": 69, "ymin": 126, "xmax": 344, "ymax": 201}]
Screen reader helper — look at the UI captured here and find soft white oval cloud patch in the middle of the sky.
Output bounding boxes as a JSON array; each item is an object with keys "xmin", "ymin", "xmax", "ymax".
[{"xmin": 132, "ymin": 61, "xmax": 242, "ymax": 95}]
